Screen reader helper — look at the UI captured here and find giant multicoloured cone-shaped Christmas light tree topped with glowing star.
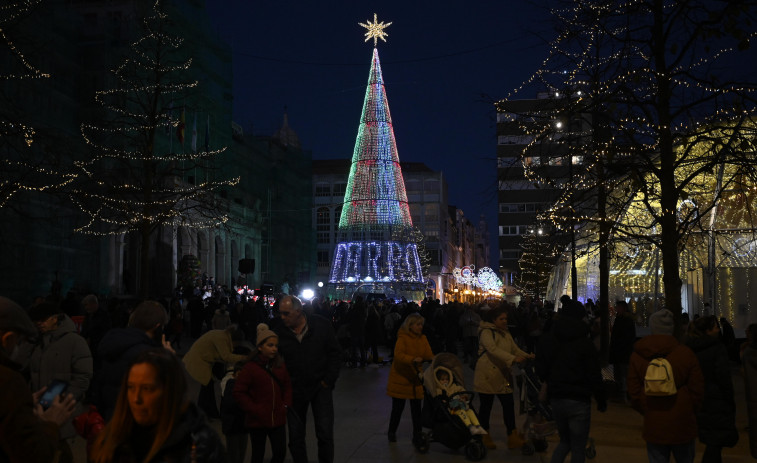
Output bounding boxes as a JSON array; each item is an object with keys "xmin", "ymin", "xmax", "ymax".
[{"xmin": 329, "ymin": 15, "xmax": 424, "ymax": 299}]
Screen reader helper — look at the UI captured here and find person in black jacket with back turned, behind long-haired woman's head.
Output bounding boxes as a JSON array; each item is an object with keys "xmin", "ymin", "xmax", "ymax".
[{"xmin": 92, "ymin": 301, "xmax": 168, "ymax": 420}]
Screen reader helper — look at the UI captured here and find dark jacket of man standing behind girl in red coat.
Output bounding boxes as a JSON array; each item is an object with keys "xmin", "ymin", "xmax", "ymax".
[{"xmin": 273, "ymin": 315, "xmax": 342, "ymax": 402}]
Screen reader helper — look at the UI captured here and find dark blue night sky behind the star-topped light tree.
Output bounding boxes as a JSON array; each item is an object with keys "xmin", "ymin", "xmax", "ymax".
[{"xmin": 208, "ymin": 0, "xmax": 550, "ymax": 268}]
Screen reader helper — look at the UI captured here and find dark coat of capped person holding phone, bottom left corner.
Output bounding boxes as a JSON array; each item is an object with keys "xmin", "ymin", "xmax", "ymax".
[{"xmin": 0, "ymin": 348, "xmax": 59, "ymax": 463}]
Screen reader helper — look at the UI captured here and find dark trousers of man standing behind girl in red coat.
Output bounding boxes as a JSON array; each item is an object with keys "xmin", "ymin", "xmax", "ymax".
[{"xmin": 287, "ymin": 386, "xmax": 334, "ymax": 463}]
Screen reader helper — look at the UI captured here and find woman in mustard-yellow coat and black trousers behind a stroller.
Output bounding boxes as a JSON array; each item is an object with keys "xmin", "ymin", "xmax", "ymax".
[{"xmin": 386, "ymin": 313, "xmax": 434, "ymax": 446}]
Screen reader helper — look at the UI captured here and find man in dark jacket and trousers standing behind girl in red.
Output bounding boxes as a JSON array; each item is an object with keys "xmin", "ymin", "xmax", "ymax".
[{"xmin": 274, "ymin": 296, "xmax": 342, "ymax": 463}]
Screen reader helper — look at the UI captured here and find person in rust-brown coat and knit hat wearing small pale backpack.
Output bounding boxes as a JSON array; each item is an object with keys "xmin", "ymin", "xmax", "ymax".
[{"xmin": 628, "ymin": 309, "xmax": 704, "ymax": 463}]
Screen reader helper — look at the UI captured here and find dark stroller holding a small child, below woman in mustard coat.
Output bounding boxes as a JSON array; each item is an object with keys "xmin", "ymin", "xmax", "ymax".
[{"xmin": 416, "ymin": 353, "xmax": 486, "ymax": 461}]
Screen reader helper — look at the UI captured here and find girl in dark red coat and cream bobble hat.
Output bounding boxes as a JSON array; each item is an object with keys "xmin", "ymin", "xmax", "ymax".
[{"xmin": 233, "ymin": 323, "xmax": 292, "ymax": 463}]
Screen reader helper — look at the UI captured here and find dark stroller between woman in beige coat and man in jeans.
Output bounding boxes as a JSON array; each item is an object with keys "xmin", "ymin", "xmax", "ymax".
[{"xmin": 519, "ymin": 362, "xmax": 557, "ymax": 455}]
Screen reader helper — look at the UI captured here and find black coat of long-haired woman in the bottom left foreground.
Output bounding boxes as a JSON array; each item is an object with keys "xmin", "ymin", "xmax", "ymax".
[{"xmin": 112, "ymin": 403, "xmax": 226, "ymax": 463}]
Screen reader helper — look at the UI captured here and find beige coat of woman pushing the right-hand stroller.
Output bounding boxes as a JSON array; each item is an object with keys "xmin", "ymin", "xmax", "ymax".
[{"xmin": 473, "ymin": 321, "xmax": 528, "ymax": 394}]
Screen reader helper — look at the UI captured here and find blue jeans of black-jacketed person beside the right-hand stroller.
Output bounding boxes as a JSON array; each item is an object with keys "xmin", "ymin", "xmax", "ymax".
[{"xmin": 550, "ymin": 399, "xmax": 591, "ymax": 463}]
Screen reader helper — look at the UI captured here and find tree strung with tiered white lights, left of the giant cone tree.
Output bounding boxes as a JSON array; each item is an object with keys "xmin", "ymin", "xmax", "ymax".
[{"xmin": 72, "ymin": 0, "xmax": 239, "ymax": 296}]
